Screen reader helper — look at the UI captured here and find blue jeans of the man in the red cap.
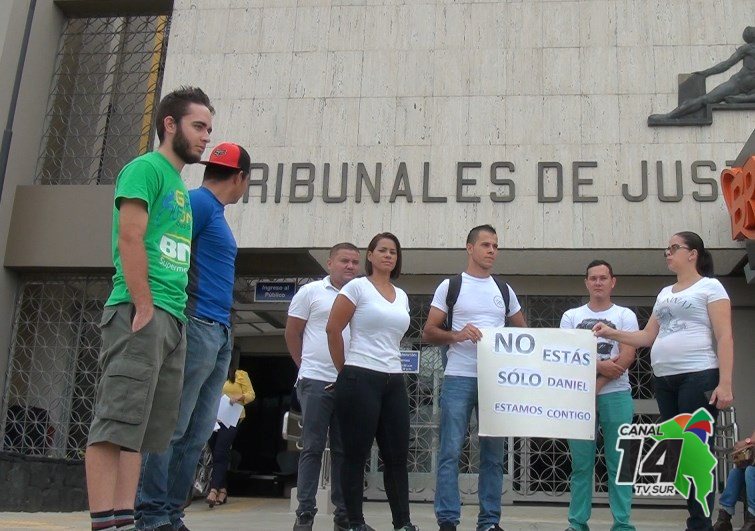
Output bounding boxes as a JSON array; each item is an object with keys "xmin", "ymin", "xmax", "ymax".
[{"xmin": 135, "ymin": 317, "xmax": 231, "ymax": 529}]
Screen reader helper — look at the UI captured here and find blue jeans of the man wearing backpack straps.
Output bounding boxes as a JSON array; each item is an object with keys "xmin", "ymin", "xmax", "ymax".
[{"xmin": 435, "ymin": 376, "xmax": 504, "ymax": 530}]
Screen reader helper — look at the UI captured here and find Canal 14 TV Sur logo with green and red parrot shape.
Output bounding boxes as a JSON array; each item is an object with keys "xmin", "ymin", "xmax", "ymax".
[{"xmin": 616, "ymin": 408, "xmax": 716, "ymax": 516}]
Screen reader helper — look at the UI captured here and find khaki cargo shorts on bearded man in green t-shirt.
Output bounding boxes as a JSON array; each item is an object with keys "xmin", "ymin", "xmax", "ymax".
[{"xmin": 87, "ymin": 304, "xmax": 186, "ymax": 452}]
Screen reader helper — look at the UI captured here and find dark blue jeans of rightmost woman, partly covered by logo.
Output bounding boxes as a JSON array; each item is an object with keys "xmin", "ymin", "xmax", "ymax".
[{"xmin": 653, "ymin": 369, "xmax": 718, "ymax": 531}]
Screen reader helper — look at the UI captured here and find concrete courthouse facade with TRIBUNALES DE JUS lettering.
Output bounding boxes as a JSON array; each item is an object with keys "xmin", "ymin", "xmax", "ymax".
[{"xmin": 0, "ymin": 0, "xmax": 755, "ymax": 512}]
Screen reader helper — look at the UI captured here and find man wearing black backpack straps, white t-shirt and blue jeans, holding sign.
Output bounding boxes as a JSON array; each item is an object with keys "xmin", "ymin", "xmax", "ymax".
[{"xmin": 422, "ymin": 225, "xmax": 527, "ymax": 531}]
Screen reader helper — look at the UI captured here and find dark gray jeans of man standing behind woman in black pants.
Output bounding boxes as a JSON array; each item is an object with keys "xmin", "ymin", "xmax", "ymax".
[{"xmin": 296, "ymin": 378, "xmax": 346, "ymax": 518}]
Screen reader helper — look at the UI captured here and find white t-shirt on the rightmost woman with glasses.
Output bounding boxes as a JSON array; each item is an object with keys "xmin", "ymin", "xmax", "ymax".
[{"xmin": 650, "ymin": 277, "xmax": 729, "ymax": 376}]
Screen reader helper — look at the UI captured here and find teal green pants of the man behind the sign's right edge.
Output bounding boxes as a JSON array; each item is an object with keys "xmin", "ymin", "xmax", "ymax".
[{"xmin": 569, "ymin": 391, "xmax": 634, "ymax": 531}]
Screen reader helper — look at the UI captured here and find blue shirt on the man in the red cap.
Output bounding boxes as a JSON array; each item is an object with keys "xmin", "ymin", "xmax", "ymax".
[{"xmin": 186, "ymin": 187, "xmax": 236, "ymax": 326}]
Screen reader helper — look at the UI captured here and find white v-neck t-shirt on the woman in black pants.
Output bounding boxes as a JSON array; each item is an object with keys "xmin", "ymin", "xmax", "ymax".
[{"xmin": 341, "ymin": 277, "xmax": 409, "ymax": 373}]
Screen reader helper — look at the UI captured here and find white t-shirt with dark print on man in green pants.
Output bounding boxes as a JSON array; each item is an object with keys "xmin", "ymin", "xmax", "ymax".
[{"xmin": 561, "ymin": 304, "xmax": 640, "ymax": 395}]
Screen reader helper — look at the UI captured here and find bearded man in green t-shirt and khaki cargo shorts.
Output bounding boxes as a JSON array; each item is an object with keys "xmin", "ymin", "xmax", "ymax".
[{"xmin": 86, "ymin": 87, "xmax": 214, "ymax": 530}]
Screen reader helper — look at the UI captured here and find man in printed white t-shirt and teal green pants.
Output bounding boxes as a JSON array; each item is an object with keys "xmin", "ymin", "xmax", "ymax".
[{"xmin": 561, "ymin": 260, "xmax": 638, "ymax": 531}]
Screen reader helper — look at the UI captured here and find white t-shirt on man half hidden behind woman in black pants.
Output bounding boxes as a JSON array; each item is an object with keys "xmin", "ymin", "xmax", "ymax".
[{"xmin": 288, "ymin": 276, "xmax": 350, "ymax": 382}]
